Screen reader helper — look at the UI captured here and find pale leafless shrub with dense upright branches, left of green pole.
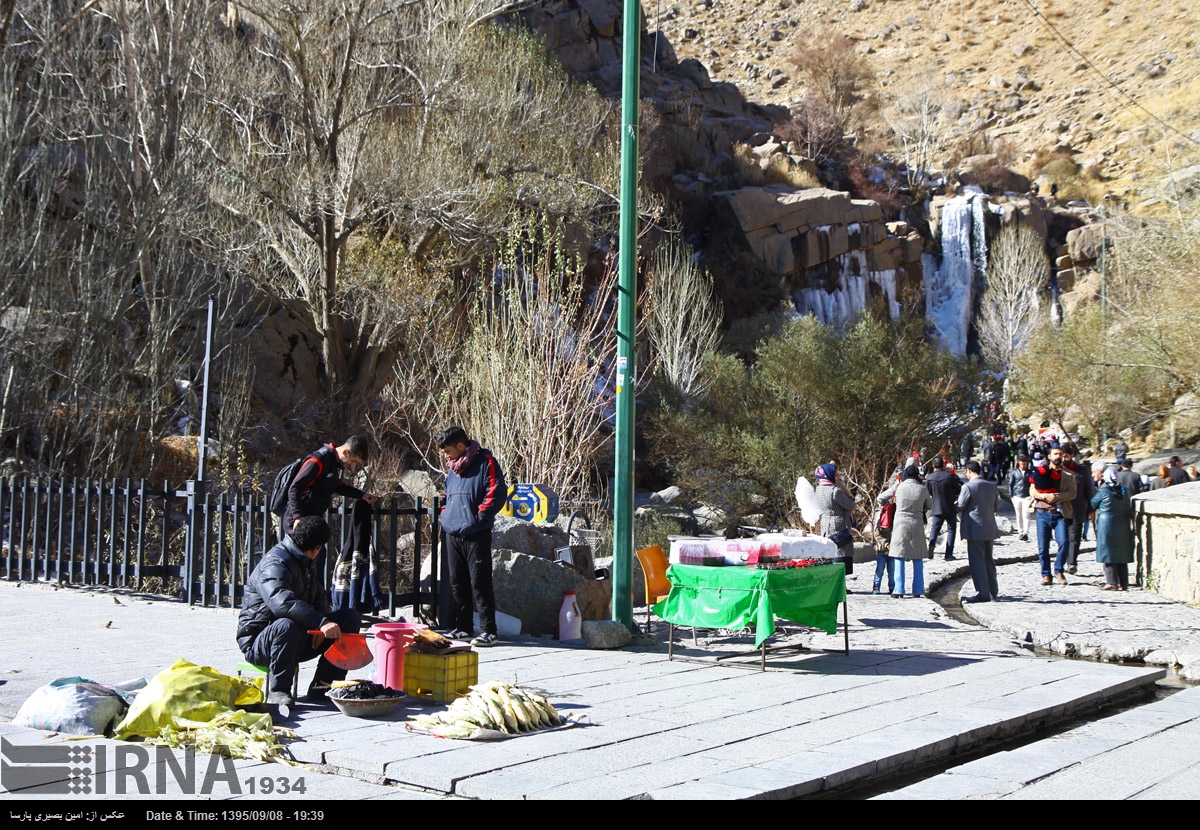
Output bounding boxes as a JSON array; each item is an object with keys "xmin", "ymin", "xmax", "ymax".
[{"xmin": 384, "ymin": 222, "xmax": 616, "ymax": 501}]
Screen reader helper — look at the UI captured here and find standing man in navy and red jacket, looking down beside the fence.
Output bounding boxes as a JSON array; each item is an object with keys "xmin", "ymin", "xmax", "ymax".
[{"xmin": 437, "ymin": 426, "xmax": 509, "ymax": 646}]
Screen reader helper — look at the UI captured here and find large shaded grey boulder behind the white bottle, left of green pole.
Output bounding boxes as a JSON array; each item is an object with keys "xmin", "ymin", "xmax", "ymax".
[{"xmin": 492, "ymin": 549, "xmax": 612, "ymax": 634}]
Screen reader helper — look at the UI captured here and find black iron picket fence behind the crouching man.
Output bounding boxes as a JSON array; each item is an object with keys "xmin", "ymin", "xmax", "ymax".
[{"xmin": 0, "ymin": 477, "xmax": 444, "ymax": 614}]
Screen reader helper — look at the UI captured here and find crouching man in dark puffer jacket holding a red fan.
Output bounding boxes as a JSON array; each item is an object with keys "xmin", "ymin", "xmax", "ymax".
[{"xmin": 238, "ymin": 516, "xmax": 362, "ymax": 708}]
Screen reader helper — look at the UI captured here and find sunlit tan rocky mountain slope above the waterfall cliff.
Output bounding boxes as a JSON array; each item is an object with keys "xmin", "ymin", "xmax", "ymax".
[{"xmin": 644, "ymin": 0, "xmax": 1200, "ymax": 210}]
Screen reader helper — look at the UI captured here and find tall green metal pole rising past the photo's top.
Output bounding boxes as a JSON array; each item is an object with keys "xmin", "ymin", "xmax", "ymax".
[{"xmin": 612, "ymin": 0, "xmax": 642, "ymax": 631}]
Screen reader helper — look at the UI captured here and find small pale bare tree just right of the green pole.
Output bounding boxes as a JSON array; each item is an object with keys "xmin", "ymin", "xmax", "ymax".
[{"xmin": 646, "ymin": 236, "xmax": 722, "ymax": 399}]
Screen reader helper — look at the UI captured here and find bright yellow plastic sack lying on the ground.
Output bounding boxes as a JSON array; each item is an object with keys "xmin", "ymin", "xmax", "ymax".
[{"xmin": 114, "ymin": 660, "xmax": 263, "ymax": 740}]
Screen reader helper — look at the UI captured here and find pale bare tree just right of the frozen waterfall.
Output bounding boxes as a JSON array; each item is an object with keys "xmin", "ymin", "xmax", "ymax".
[{"xmin": 976, "ymin": 221, "xmax": 1050, "ymax": 372}]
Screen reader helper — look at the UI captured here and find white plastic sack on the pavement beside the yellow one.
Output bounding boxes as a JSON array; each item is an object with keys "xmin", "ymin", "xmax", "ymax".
[{"xmin": 13, "ymin": 678, "xmax": 144, "ymax": 735}]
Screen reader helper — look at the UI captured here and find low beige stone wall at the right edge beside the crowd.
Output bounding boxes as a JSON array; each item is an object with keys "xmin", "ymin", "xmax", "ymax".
[{"xmin": 1135, "ymin": 513, "xmax": 1200, "ymax": 605}]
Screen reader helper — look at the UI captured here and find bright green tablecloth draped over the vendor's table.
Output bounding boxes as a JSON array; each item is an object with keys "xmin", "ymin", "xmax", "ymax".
[{"xmin": 654, "ymin": 563, "xmax": 846, "ymax": 648}]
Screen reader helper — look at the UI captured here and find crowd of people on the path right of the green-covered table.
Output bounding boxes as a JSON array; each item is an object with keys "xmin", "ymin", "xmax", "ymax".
[{"xmin": 816, "ymin": 437, "xmax": 1152, "ymax": 602}]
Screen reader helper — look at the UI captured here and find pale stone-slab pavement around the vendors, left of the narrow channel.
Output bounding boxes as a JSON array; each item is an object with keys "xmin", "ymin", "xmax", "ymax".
[{"xmin": 0, "ymin": 563, "xmax": 1190, "ymax": 800}]
